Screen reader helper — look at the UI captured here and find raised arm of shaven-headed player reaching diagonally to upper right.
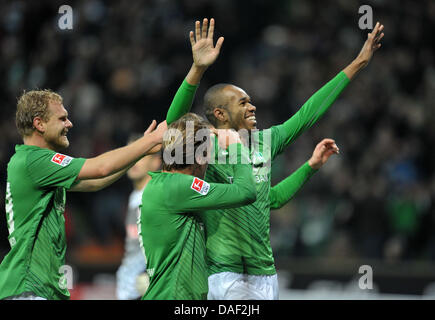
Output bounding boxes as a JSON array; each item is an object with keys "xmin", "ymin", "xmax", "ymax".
[{"xmin": 274, "ymin": 22, "xmax": 384, "ymax": 156}]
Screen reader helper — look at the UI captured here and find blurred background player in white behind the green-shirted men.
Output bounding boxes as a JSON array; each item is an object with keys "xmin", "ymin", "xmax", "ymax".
[{"xmin": 116, "ymin": 135, "xmax": 162, "ymax": 300}]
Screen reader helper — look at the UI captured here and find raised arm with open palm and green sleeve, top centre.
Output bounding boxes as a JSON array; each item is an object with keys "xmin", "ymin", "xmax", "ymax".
[{"xmin": 166, "ymin": 18, "xmax": 224, "ymax": 125}]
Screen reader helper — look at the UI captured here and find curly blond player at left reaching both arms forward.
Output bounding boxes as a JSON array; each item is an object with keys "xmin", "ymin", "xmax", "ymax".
[{"xmin": 0, "ymin": 90, "xmax": 167, "ymax": 299}]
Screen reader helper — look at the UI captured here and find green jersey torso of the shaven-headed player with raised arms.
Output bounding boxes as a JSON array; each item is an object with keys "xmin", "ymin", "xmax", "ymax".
[{"xmin": 201, "ymin": 126, "xmax": 314, "ymax": 275}]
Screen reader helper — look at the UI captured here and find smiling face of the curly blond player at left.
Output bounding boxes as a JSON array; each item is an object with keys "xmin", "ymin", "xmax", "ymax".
[{"xmin": 43, "ymin": 101, "xmax": 73, "ymax": 151}]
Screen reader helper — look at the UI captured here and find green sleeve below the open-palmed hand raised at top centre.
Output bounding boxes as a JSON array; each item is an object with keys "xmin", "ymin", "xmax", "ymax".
[{"xmin": 166, "ymin": 79, "xmax": 198, "ymax": 125}]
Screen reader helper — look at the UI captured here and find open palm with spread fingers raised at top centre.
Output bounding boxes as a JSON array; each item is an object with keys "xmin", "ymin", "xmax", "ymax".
[{"xmin": 189, "ymin": 18, "xmax": 224, "ymax": 68}]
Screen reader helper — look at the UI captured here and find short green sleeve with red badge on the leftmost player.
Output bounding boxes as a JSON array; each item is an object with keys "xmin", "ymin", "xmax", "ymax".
[{"xmin": 26, "ymin": 149, "xmax": 86, "ymax": 189}]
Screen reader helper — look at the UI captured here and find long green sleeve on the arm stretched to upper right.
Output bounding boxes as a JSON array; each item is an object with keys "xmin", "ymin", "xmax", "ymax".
[{"xmin": 271, "ymin": 71, "xmax": 350, "ymax": 159}]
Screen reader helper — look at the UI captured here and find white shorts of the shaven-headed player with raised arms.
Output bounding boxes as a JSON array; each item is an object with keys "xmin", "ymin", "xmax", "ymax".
[{"xmin": 207, "ymin": 272, "xmax": 279, "ymax": 300}]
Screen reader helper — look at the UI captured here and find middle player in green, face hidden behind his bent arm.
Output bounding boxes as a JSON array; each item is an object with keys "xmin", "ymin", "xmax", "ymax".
[{"xmin": 139, "ymin": 113, "xmax": 256, "ymax": 300}]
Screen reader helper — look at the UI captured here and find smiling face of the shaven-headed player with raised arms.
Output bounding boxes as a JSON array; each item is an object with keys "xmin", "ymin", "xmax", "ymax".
[{"xmin": 224, "ymin": 86, "xmax": 257, "ymax": 131}]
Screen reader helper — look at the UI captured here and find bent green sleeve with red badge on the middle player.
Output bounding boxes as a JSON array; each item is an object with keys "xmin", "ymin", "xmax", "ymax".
[{"xmin": 175, "ymin": 144, "xmax": 256, "ymax": 212}]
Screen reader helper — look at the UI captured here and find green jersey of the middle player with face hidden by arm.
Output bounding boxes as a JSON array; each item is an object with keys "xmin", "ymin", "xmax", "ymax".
[{"xmin": 138, "ymin": 145, "xmax": 255, "ymax": 300}]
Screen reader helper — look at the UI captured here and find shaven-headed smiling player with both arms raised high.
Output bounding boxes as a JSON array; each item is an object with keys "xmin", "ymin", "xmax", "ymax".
[{"xmin": 166, "ymin": 19, "xmax": 384, "ymax": 300}]
